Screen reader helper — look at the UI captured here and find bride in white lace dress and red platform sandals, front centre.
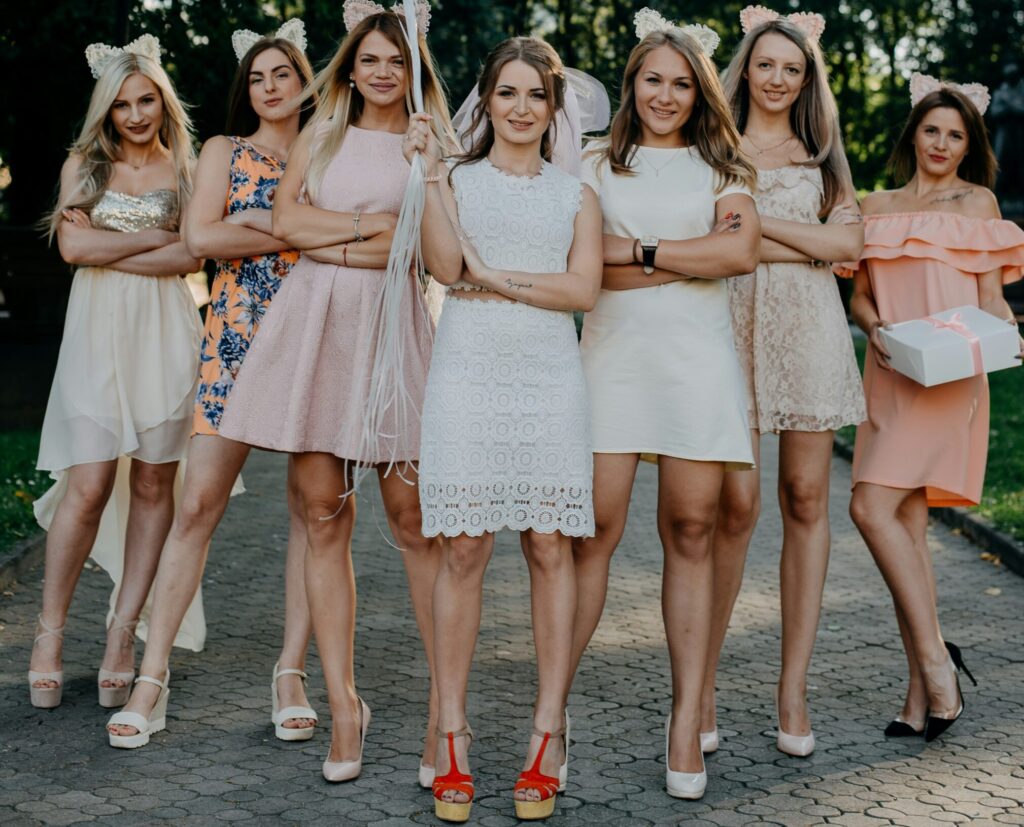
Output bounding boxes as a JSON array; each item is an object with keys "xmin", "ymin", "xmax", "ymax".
[{"xmin": 406, "ymin": 38, "xmax": 601, "ymax": 820}]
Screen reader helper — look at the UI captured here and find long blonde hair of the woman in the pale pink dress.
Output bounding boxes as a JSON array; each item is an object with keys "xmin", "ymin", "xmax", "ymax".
[{"xmin": 297, "ymin": 11, "xmax": 455, "ymax": 198}]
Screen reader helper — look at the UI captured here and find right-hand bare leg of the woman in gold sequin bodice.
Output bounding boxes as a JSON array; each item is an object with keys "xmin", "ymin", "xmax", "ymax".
[{"xmin": 101, "ymin": 460, "xmax": 178, "ymax": 687}]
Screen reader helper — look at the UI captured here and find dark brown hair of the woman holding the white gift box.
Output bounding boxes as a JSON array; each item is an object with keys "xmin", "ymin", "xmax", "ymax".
[{"xmin": 889, "ymin": 87, "xmax": 998, "ymax": 189}]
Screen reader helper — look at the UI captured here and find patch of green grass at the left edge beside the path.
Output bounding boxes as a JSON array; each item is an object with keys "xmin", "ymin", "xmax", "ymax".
[{"xmin": 0, "ymin": 431, "xmax": 50, "ymax": 549}]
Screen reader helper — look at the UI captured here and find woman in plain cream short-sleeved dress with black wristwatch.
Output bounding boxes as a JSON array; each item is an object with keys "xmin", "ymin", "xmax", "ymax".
[{"xmin": 572, "ymin": 10, "xmax": 760, "ymax": 798}]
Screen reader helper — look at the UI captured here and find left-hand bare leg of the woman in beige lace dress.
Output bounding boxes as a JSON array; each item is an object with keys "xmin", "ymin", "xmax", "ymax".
[{"xmin": 700, "ymin": 431, "xmax": 761, "ymax": 732}]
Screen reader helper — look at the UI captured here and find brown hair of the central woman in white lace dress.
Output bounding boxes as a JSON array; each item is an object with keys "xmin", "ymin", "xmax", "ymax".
[{"xmin": 452, "ymin": 37, "xmax": 565, "ymax": 177}]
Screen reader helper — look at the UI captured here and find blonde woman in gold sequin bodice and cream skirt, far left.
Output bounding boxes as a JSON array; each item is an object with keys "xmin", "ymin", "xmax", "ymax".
[{"xmin": 29, "ymin": 35, "xmax": 202, "ymax": 707}]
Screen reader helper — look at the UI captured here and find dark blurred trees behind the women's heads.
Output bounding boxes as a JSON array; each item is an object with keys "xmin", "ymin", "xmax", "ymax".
[{"xmin": 0, "ymin": 0, "xmax": 1024, "ymax": 225}]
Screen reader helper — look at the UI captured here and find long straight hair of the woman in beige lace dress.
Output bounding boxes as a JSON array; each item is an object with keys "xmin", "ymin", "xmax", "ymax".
[{"xmin": 722, "ymin": 18, "xmax": 853, "ymax": 217}]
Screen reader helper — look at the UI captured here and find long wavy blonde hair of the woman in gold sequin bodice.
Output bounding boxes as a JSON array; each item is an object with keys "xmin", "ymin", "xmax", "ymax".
[{"xmin": 43, "ymin": 52, "xmax": 196, "ymax": 241}]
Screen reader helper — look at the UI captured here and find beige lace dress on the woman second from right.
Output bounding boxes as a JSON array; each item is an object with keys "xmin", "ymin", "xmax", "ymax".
[{"xmin": 726, "ymin": 166, "xmax": 866, "ymax": 433}]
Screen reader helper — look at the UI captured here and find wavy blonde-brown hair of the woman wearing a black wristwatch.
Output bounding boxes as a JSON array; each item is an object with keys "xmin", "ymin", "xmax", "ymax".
[{"xmin": 596, "ymin": 29, "xmax": 758, "ymax": 192}]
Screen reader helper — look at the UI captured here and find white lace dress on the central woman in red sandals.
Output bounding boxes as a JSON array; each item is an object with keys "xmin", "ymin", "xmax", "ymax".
[{"xmin": 420, "ymin": 160, "xmax": 594, "ymax": 537}]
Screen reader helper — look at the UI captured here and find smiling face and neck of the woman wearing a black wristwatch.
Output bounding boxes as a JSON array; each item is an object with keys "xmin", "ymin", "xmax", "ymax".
[{"xmin": 633, "ymin": 46, "xmax": 698, "ymax": 146}]
